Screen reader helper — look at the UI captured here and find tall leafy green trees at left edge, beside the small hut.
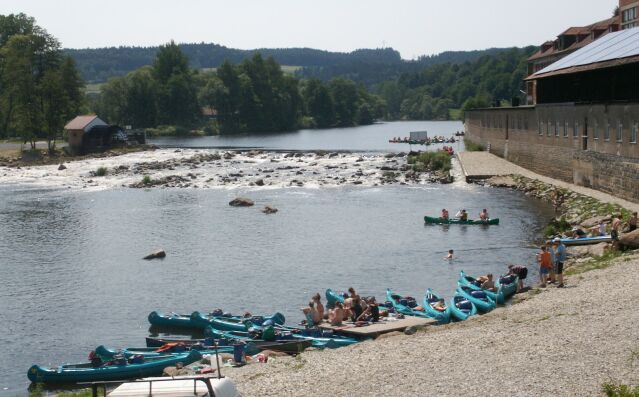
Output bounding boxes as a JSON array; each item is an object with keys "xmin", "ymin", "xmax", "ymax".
[{"xmin": 0, "ymin": 14, "xmax": 84, "ymax": 151}]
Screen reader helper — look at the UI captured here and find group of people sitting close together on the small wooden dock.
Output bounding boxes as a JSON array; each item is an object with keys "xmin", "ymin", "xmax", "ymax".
[{"xmin": 302, "ymin": 287, "xmax": 380, "ymax": 327}]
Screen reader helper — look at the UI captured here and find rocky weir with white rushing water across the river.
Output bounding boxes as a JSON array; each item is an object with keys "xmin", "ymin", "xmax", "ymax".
[{"xmin": 0, "ymin": 149, "xmax": 450, "ymax": 189}]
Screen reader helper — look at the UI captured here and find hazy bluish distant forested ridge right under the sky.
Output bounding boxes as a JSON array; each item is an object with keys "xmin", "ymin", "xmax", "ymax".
[{"xmin": 65, "ymin": 43, "xmax": 524, "ymax": 85}]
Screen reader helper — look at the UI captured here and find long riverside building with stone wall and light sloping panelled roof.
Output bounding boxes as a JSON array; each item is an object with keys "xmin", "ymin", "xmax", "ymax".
[{"xmin": 465, "ymin": 23, "xmax": 639, "ymax": 202}]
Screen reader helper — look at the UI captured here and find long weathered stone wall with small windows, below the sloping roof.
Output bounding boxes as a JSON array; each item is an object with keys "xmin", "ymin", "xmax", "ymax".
[{"xmin": 466, "ymin": 103, "xmax": 639, "ymax": 202}]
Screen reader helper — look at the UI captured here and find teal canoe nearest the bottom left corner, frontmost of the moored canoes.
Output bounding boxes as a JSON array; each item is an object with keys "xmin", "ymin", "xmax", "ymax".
[{"xmin": 27, "ymin": 350, "xmax": 202, "ymax": 384}]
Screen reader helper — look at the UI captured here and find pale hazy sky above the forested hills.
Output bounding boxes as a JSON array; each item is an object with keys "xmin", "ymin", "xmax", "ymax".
[{"xmin": 0, "ymin": 0, "xmax": 618, "ymax": 59}]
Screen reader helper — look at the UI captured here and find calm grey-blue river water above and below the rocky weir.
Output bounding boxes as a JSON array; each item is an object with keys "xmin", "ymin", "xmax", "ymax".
[{"xmin": 0, "ymin": 122, "xmax": 552, "ymax": 396}]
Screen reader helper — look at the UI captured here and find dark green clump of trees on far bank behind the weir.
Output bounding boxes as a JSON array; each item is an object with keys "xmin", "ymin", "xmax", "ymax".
[{"xmin": 92, "ymin": 42, "xmax": 385, "ymax": 134}]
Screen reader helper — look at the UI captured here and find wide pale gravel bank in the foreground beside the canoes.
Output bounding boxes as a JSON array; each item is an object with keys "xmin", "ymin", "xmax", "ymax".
[{"xmin": 223, "ymin": 255, "xmax": 639, "ymax": 396}]
